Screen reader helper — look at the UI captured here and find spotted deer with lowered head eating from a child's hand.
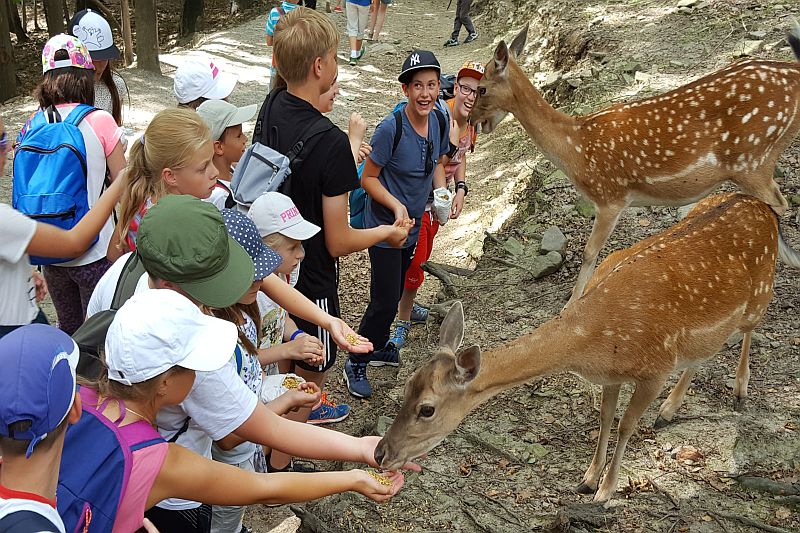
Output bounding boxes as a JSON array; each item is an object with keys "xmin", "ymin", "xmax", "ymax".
[{"xmin": 375, "ymin": 193, "xmax": 800, "ymax": 501}]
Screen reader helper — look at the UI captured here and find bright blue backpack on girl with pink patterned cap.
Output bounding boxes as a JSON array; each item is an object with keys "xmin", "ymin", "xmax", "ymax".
[{"xmin": 11, "ymin": 104, "xmax": 97, "ymax": 265}]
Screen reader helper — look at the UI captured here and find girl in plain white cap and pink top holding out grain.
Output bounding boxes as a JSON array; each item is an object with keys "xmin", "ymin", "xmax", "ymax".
[{"xmin": 72, "ymin": 290, "xmax": 403, "ymax": 533}]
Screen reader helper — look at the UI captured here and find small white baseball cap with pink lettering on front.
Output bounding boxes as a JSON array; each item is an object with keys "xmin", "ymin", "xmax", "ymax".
[{"xmin": 247, "ymin": 192, "xmax": 320, "ymax": 241}]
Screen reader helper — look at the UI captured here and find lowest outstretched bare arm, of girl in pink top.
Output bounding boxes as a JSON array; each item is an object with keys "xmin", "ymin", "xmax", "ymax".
[{"xmin": 146, "ymin": 444, "xmax": 404, "ymax": 508}]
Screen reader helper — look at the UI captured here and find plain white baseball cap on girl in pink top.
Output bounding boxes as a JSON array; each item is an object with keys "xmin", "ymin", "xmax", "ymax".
[{"xmin": 106, "ymin": 289, "xmax": 238, "ymax": 386}]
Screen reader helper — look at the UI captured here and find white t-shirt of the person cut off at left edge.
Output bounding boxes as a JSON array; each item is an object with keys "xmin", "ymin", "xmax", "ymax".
[{"xmin": 0, "ymin": 203, "xmax": 39, "ymax": 326}]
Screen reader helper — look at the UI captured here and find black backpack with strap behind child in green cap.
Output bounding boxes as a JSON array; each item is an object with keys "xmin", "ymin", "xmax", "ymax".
[{"xmin": 72, "ymin": 252, "xmax": 145, "ymax": 380}]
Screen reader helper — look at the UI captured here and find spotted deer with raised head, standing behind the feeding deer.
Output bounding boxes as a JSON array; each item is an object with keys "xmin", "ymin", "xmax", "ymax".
[{"xmin": 470, "ymin": 23, "xmax": 800, "ymax": 305}]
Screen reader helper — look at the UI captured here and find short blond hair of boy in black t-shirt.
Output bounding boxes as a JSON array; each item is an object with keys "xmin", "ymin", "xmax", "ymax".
[{"xmin": 272, "ymin": 7, "xmax": 339, "ymax": 83}]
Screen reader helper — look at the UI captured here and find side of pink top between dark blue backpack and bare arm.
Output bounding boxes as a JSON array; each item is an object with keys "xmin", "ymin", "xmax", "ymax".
[{"xmin": 111, "ymin": 442, "xmax": 169, "ymax": 533}]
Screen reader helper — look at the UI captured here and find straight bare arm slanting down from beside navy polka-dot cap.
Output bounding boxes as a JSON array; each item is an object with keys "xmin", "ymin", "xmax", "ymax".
[{"xmin": 261, "ymin": 274, "xmax": 380, "ymax": 353}]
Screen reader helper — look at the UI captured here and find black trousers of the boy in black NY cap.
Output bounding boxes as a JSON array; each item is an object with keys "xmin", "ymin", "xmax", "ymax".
[{"xmin": 350, "ymin": 242, "xmax": 415, "ymax": 362}]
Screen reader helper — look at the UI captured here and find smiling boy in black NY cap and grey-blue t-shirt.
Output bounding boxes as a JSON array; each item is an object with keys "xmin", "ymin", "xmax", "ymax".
[{"xmin": 344, "ymin": 50, "xmax": 457, "ymax": 398}]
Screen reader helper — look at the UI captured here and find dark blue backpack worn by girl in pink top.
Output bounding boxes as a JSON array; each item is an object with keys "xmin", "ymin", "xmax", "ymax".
[{"xmin": 56, "ymin": 387, "xmax": 165, "ymax": 533}]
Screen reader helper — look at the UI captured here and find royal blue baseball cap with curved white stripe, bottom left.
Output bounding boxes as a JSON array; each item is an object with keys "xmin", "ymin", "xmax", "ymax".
[{"xmin": 0, "ymin": 324, "xmax": 80, "ymax": 457}]
